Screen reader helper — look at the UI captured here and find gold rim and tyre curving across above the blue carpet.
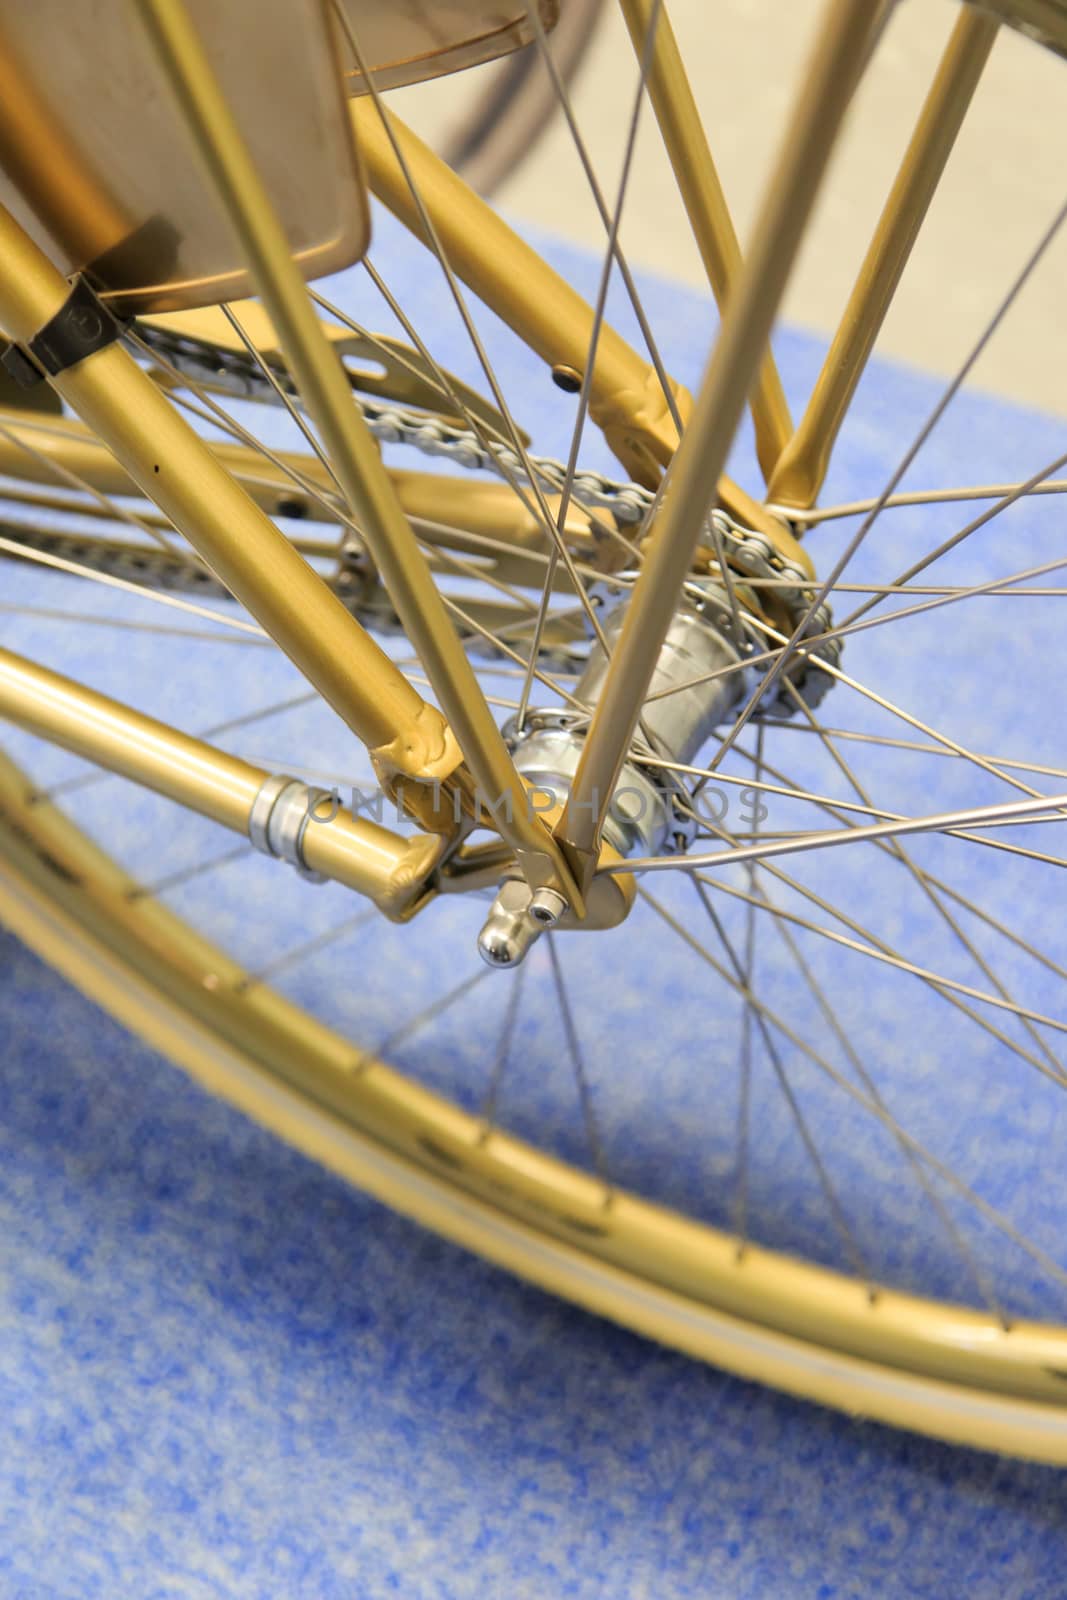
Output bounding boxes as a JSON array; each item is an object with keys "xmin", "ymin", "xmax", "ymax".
[{"xmin": 0, "ymin": 758, "xmax": 1067, "ymax": 1462}]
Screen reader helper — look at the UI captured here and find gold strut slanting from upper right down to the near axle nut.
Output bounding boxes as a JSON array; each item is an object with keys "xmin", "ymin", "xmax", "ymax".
[{"xmin": 557, "ymin": 0, "xmax": 881, "ymax": 861}]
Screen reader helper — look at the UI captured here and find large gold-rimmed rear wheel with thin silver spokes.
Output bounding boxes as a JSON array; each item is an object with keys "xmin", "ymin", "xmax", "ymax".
[{"xmin": 0, "ymin": 0, "xmax": 1067, "ymax": 1461}]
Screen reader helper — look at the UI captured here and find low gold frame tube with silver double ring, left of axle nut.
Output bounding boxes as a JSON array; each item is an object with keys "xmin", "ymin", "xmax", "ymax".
[{"xmin": 0, "ymin": 636, "xmax": 442, "ymax": 917}]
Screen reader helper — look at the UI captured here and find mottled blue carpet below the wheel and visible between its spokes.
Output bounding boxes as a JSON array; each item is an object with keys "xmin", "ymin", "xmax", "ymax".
[{"xmin": 0, "ymin": 216, "xmax": 1067, "ymax": 1600}]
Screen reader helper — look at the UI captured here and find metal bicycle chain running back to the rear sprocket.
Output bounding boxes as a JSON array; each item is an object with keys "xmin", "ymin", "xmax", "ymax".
[{"xmin": 6, "ymin": 326, "xmax": 841, "ymax": 715}]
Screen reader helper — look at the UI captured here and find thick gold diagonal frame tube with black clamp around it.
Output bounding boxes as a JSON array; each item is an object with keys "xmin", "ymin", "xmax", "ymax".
[{"xmin": 0, "ymin": 208, "xmax": 443, "ymax": 768}]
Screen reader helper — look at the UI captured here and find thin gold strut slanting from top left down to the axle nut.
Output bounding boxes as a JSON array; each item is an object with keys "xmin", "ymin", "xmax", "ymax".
[{"xmin": 138, "ymin": 0, "xmax": 581, "ymax": 902}]
